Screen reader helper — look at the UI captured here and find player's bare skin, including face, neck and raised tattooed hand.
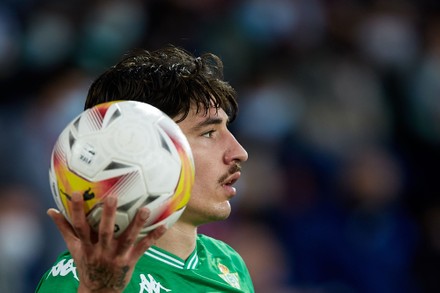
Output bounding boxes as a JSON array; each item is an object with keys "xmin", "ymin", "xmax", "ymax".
[{"xmin": 48, "ymin": 104, "xmax": 248, "ymax": 293}]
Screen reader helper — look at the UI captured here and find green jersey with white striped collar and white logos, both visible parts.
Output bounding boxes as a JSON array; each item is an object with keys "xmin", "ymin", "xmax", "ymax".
[{"xmin": 36, "ymin": 234, "xmax": 254, "ymax": 293}]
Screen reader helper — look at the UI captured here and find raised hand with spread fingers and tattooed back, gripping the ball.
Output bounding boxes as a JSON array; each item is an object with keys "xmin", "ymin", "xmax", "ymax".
[{"xmin": 47, "ymin": 194, "xmax": 166, "ymax": 293}]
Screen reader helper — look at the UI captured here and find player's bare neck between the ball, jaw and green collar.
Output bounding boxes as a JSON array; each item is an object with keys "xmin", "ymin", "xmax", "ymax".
[{"xmin": 155, "ymin": 221, "xmax": 197, "ymax": 260}]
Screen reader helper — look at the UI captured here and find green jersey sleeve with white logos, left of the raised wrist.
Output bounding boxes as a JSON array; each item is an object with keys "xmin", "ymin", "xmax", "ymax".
[{"xmin": 35, "ymin": 253, "xmax": 79, "ymax": 293}]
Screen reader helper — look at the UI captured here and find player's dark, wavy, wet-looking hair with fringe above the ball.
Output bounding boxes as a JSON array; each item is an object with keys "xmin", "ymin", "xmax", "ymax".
[{"xmin": 84, "ymin": 46, "xmax": 238, "ymax": 121}]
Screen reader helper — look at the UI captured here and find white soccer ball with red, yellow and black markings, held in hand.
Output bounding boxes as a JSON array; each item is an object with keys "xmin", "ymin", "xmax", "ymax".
[{"xmin": 49, "ymin": 101, "xmax": 194, "ymax": 238}]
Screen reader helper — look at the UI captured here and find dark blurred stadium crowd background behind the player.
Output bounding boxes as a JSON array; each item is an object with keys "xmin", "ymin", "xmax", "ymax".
[{"xmin": 0, "ymin": 0, "xmax": 440, "ymax": 293}]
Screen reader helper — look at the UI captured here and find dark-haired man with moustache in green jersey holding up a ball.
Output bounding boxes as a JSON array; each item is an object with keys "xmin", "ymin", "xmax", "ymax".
[{"xmin": 37, "ymin": 46, "xmax": 254, "ymax": 293}]
